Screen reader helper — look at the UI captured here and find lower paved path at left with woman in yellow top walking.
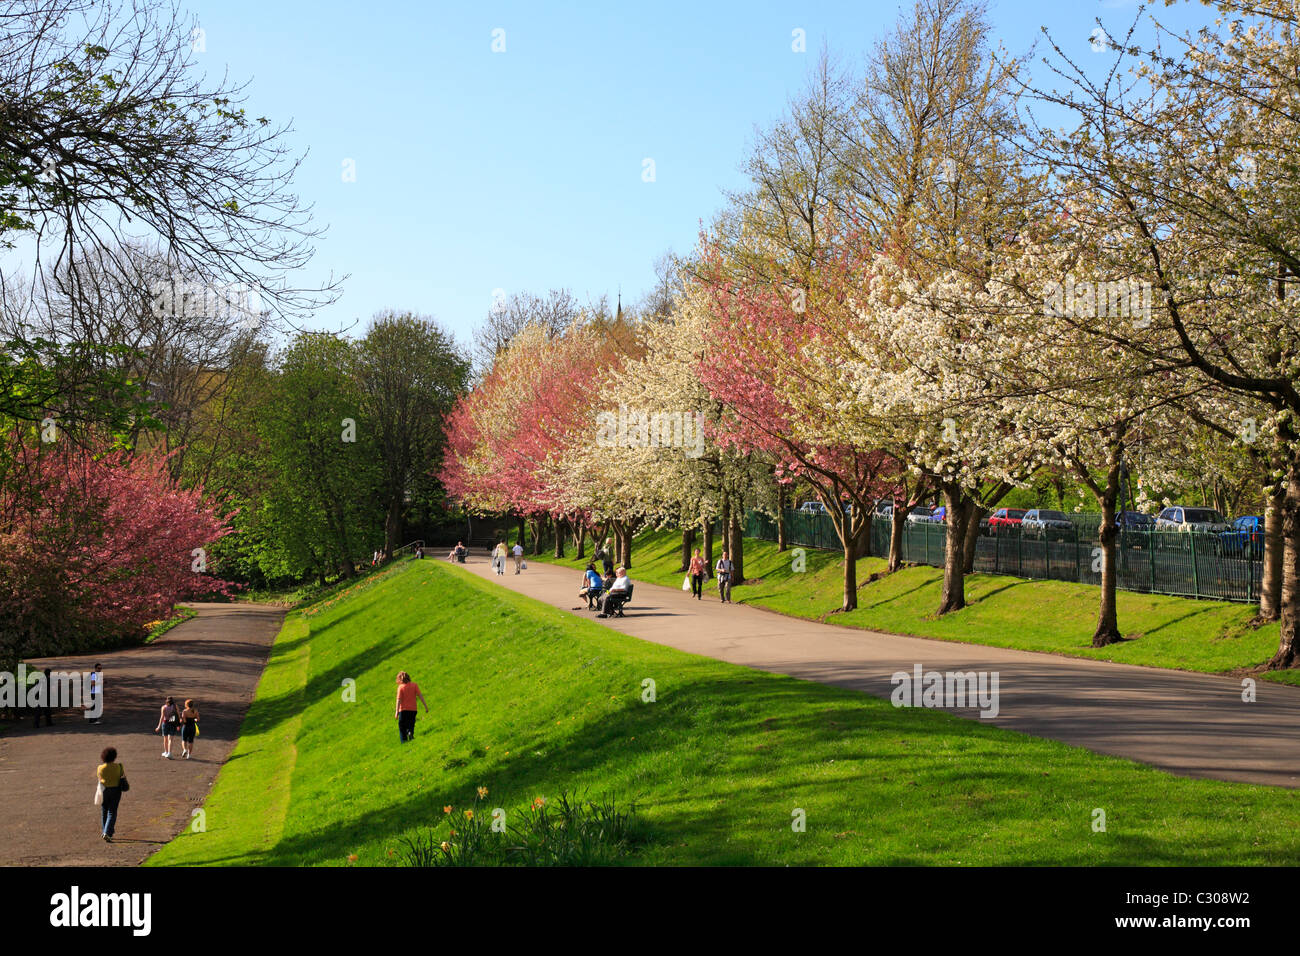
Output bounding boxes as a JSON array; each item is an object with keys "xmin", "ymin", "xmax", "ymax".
[{"xmin": 0, "ymin": 604, "xmax": 285, "ymax": 866}]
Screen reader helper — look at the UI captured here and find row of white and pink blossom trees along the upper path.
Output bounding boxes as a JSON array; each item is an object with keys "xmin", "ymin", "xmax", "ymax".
[{"xmin": 447, "ymin": 0, "xmax": 1300, "ymax": 667}]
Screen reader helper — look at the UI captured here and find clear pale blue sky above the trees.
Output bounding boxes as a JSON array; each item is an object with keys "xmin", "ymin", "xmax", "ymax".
[{"xmin": 189, "ymin": 0, "xmax": 1210, "ymax": 341}]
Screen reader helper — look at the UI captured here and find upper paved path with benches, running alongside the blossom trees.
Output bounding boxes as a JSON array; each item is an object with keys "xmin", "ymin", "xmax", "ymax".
[{"xmin": 465, "ymin": 555, "xmax": 1300, "ymax": 788}]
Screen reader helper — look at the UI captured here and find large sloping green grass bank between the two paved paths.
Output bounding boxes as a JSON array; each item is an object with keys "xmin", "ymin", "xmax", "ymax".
[{"xmin": 148, "ymin": 561, "xmax": 1300, "ymax": 865}]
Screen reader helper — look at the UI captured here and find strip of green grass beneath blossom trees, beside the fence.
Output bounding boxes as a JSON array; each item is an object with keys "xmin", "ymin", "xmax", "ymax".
[{"xmin": 541, "ymin": 531, "xmax": 1300, "ymax": 684}]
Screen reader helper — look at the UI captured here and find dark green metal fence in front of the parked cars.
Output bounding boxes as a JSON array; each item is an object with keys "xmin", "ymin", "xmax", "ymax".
[{"xmin": 745, "ymin": 510, "xmax": 1264, "ymax": 602}]
